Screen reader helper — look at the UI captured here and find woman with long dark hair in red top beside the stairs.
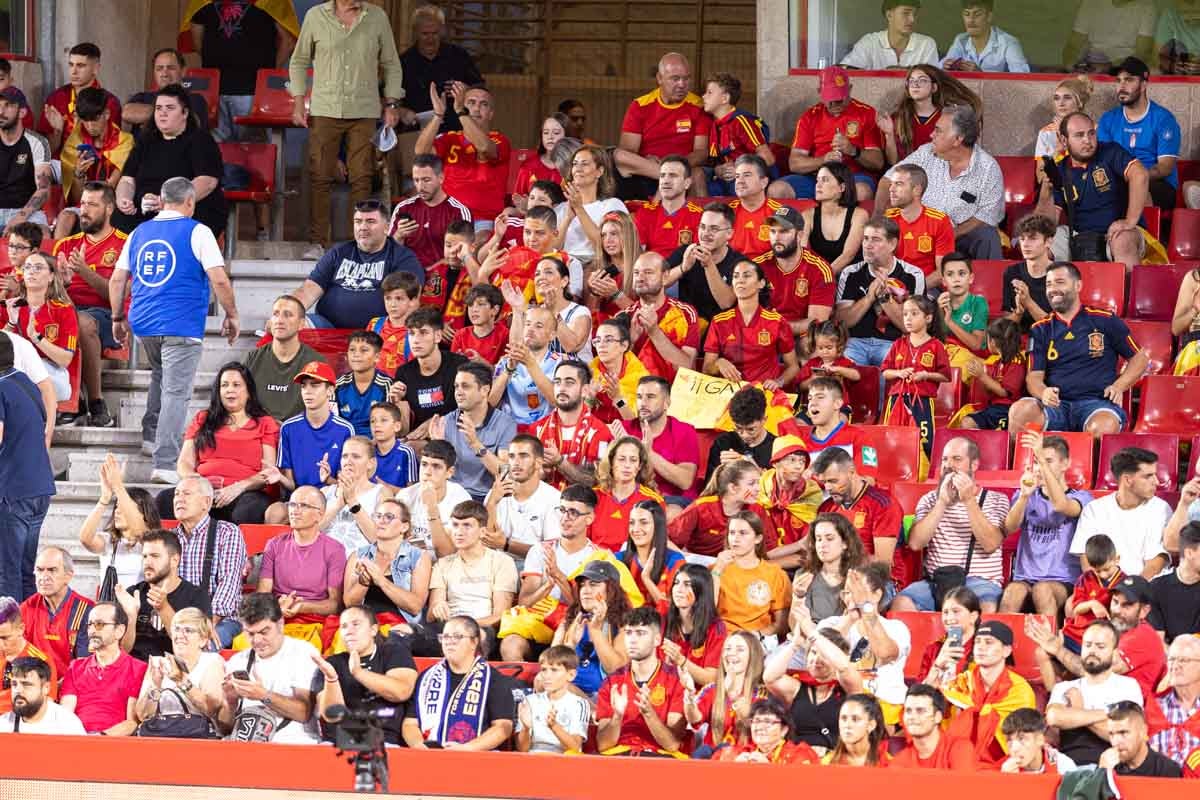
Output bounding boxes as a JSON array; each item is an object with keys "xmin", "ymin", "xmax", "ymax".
[{"xmin": 157, "ymin": 361, "xmax": 280, "ymax": 525}]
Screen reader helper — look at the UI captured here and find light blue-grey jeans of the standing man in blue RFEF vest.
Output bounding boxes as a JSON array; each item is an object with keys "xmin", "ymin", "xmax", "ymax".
[{"xmin": 138, "ymin": 336, "xmax": 204, "ymax": 470}]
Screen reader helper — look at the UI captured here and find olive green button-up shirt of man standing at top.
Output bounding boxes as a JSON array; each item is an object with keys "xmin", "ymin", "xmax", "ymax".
[{"xmin": 288, "ymin": 0, "xmax": 404, "ymax": 120}]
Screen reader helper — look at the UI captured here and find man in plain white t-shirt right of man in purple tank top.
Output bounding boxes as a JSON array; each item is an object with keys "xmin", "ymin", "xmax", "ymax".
[{"xmin": 1070, "ymin": 447, "xmax": 1171, "ymax": 581}]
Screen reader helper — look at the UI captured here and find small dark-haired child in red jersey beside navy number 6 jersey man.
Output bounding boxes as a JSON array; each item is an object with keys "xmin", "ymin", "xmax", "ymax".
[{"xmin": 948, "ymin": 318, "xmax": 1025, "ymax": 431}]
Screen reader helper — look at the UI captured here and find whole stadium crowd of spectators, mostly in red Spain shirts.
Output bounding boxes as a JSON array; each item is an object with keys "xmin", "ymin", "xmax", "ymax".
[{"xmin": 0, "ymin": 0, "xmax": 1200, "ymax": 783}]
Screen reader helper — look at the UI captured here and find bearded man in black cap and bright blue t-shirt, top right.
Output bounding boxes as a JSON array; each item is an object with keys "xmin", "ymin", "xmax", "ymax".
[{"xmin": 1097, "ymin": 56, "xmax": 1180, "ymax": 210}]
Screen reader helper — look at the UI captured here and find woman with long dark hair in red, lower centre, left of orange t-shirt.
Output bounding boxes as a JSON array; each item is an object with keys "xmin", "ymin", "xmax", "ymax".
[{"xmin": 662, "ymin": 564, "xmax": 728, "ymax": 686}]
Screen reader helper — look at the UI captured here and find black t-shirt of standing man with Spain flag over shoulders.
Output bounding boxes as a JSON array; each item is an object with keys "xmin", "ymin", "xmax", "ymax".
[{"xmin": 192, "ymin": 0, "xmax": 283, "ymax": 97}]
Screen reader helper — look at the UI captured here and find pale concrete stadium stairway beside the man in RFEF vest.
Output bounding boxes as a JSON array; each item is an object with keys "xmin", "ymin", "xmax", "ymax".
[{"xmin": 41, "ymin": 257, "xmax": 313, "ymax": 596}]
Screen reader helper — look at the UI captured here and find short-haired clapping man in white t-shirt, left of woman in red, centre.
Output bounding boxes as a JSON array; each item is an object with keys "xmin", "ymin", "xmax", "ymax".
[{"xmin": 484, "ymin": 433, "xmax": 562, "ymax": 573}]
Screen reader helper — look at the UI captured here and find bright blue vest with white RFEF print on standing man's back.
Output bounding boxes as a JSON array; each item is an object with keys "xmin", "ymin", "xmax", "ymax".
[{"xmin": 125, "ymin": 217, "xmax": 209, "ymax": 339}]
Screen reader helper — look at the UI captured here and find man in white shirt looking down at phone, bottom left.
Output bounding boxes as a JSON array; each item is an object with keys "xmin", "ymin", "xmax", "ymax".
[{"xmin": 217, "ymin": 591, "xmax": 320, "ymax": 745}]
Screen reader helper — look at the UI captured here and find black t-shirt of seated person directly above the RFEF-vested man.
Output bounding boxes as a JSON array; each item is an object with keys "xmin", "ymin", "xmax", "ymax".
[{"xmin": 124, "ymin": 122, "xmax": 226, "ymax": 236}]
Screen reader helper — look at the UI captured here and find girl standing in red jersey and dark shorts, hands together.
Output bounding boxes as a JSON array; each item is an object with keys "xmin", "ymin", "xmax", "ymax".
[{"xmin": 882, "ymin": 296, "xmax": 950, "ymax": 479}]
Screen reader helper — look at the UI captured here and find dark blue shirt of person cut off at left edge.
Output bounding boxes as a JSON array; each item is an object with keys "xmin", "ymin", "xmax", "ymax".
[{"xmin": 0, "ymin": 369, "xmax": 54, "ymax": 501}]
